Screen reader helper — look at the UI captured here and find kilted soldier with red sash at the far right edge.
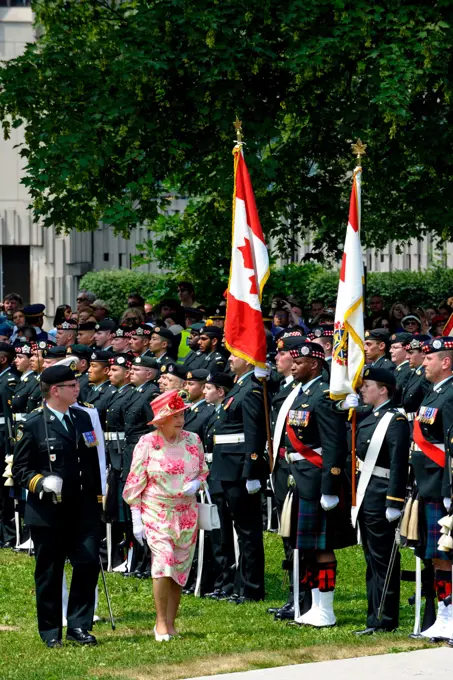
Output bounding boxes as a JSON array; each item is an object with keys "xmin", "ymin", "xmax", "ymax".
[{"xmin": 411, "ymin": 337, "xmax": 453, "ymax": 640}]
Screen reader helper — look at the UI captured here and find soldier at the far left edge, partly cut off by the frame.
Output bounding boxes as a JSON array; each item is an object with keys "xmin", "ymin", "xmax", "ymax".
[{"xmin": 0, "ymin": 342, "xmax": 19, "ymax": 548}]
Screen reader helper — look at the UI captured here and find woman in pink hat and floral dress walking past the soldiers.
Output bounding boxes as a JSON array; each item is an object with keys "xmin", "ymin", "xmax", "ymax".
[{"xmin": 123, "ymin": 390, "xmax": 208, "ymax": 642}]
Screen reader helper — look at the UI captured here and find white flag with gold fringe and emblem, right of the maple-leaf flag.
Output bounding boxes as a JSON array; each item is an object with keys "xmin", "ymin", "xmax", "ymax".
[{"xmin": 330, "ymin": 167, "xmax": 365, "ymax": 399}]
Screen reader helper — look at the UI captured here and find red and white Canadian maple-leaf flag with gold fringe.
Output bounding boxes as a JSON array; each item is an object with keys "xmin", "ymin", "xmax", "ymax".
[{"xmin": 225, "ymin": 144, "xmax": 270, "ymax": 368}]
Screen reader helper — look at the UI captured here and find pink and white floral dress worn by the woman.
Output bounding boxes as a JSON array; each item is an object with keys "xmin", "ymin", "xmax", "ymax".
[{"xmin": 123, "ymin": 430, "xmax": 208, "ymax": 586}]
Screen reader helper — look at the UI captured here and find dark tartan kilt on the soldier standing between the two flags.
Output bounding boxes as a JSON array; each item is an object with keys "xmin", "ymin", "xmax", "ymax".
[{"xmin": 296, "ymin": 487, "xmax": 357, "ymax": 550}]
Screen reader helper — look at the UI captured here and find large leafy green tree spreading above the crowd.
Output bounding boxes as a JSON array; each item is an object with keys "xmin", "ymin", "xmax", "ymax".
[{"xmin": 0, "ymin": 0, "xmax": 453, "ymax": 274}]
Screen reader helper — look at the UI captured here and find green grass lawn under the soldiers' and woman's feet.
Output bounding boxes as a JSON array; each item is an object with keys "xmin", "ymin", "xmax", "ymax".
[{"xmin": 0, "ymin": 534, "xmax": 429, "ymax": 680}]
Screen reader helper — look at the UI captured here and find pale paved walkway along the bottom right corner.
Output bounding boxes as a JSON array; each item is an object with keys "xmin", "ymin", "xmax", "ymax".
[{"xmin": 184, "ymin": 647, "xmax": 453, "ymax": 680}]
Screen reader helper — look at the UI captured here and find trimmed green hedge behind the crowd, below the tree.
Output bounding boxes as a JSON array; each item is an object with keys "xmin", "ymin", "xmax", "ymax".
[{"xmin": 80, "ymin": 263, "xmax": 453, "ymax": 316}]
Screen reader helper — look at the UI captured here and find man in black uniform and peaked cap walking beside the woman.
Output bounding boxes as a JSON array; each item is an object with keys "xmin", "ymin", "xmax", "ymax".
[{"xmin": 13, "ymin": 366, "xmax": 102, "ymax": 647}]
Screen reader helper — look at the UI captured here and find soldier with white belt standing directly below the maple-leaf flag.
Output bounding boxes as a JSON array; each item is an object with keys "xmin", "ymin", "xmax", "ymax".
[{"xmin": 210, "ymin": 354, "xmax": 268, "ymax": 604}]
